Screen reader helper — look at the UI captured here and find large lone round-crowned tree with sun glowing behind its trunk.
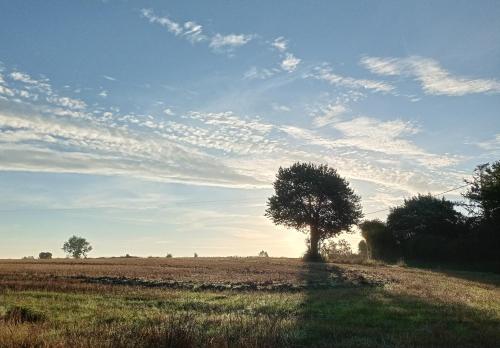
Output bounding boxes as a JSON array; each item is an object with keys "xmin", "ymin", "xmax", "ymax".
[{"xmin": 266, "ymin": 163, "xmax": 362, "ymax": 260}]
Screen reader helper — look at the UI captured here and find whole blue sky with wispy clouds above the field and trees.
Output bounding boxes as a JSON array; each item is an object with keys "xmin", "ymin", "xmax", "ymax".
[{"xmin": 0, "ymin": 0, "xmax": 500, "ymax": 258}]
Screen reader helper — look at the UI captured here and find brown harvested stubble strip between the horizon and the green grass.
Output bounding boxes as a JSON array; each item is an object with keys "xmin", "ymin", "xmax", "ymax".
[{"xmin": 0, "ymin": 258, "xmax": 392, "ymax": 291}]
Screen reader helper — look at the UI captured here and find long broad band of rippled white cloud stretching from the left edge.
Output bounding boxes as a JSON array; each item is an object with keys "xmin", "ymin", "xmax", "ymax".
[{"xmin": 0, "ymin": 62, "xmax": 466, "ymax": 198}]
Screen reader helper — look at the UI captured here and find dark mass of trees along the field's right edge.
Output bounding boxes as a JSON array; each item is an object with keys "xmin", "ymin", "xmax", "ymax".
[{"xmin": 360, "ymin": 161, "xmax": 500, "ymax": 271}]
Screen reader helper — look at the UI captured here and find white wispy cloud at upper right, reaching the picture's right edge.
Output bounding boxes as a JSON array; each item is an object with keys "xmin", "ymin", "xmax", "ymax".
[{"xmin": 360, "ymin": 56, "xmax": 500, "ymax": 96}]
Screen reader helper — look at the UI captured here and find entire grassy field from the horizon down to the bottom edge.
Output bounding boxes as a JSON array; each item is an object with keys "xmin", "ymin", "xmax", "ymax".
[{"xmin": 0, "ymin": 259, "xmax": 500, "ymax": 347}]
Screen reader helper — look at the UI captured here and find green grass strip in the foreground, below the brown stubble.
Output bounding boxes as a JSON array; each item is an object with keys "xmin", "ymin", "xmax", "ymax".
[{"xmin": 0, "ymin": 288, "xmax": 500, "ymax": 347}]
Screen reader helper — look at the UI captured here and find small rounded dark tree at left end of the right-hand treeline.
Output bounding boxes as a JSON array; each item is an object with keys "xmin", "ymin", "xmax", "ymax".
[{"xmin": 359, "ymin": 219, "xmax": 397, "ymax": 261}]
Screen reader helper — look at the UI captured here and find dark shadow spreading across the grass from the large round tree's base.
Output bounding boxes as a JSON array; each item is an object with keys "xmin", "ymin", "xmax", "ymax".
[{"xmin": 294, "ymin": 263, "xmax": 500, "ymax": 347}]
